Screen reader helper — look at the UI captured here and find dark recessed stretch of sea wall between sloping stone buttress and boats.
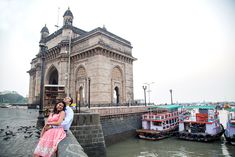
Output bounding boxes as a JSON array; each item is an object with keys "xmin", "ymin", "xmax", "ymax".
[{"xmin": 101, "ymin": 113, "xmax": 142, "ymax": 145}]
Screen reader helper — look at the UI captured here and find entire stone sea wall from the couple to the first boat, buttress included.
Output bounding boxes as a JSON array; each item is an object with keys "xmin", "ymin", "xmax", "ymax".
[{"xmin": 70, "ymin": 109, "xmax": 143, "ymax": 157}]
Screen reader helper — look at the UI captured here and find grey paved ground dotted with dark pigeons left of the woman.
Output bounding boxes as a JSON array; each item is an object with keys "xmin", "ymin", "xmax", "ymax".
[{"xmin": 0, "ymin": 108, "xmax": 40, "ymax": 157}]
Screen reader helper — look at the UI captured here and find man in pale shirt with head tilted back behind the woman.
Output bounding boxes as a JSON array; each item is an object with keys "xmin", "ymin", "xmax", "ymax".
[{"xmin": 61, "ymin": 97, "xmax": 74, "ymax": 132}]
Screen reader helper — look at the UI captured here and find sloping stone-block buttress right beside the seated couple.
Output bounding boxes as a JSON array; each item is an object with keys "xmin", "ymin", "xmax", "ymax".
[{"xmin": 70, "ymin": 113, "xmax": 106, "ymax": 157}]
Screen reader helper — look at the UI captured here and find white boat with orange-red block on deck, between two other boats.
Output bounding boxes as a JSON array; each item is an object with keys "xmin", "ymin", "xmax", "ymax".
[{"xmin": 177, "ymin": 105, "xmax": 224, "ymax": 142}]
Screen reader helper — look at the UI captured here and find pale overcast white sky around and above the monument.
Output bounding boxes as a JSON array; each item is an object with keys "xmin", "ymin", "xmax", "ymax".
[{"xmin": 0, "ymin": 0, "xmax": 235, "ymax": 104}]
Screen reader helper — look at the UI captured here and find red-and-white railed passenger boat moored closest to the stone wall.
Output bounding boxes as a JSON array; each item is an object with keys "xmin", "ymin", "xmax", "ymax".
[{"xmin": 136, "ymin": 105, "xmax": 181, "ymax": 141}]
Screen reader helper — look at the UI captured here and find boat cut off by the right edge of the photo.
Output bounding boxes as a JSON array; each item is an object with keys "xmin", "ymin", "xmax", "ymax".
[{"xmin": 224, "ymin": 108, "xmax": 235, "ymax": 145}]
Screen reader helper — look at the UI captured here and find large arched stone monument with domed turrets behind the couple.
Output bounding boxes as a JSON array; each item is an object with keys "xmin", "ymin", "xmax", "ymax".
[{"xmin": 28, "ymin": 8, "xmax": 136, "ymax": 106}]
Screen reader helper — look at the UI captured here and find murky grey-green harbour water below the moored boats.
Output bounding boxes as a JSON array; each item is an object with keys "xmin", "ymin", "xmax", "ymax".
[{"xmin": 107, "ymin": 111, "xmax": 235, "ymax": 157}]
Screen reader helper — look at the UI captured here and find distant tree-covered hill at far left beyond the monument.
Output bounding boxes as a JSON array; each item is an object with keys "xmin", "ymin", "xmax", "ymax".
[{"xmin": 0, "ymin": 91, "xmax": 27, "ymax": 104}]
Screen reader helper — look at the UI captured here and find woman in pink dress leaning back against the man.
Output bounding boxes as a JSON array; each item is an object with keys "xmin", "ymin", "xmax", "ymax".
[{"xmin": 34, "ymin": 102, "xmax": 66, "ymax": 157}]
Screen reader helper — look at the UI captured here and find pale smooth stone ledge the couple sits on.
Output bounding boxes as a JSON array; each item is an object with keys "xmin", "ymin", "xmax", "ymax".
[{"xmin": 58, "ymin": 130, "xmax": 88, "ymax": 157}]
